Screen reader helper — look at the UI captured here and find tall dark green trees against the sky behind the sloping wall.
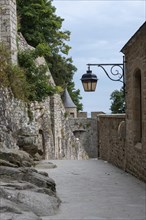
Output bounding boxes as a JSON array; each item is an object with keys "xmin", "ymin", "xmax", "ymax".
[{"xmin": 17, "ymin": 0, "xmax": 82, "ymax": 110}]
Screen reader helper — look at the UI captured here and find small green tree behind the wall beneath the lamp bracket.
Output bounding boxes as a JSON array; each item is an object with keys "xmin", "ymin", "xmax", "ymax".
[{"xmin": 110, "ymin": 88, "xmax": 125, "ymax": 114}]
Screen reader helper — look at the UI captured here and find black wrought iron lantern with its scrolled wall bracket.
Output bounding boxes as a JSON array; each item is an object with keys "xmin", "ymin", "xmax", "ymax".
[{"xmin": 81, "ymin": 57, "xmax": 125, "ymax": 92}]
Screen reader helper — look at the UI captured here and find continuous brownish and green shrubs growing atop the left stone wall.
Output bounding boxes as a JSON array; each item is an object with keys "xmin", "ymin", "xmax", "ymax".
[{"xmin": 0, "ymin": 44, "xmax": 59, "ymax": 102}]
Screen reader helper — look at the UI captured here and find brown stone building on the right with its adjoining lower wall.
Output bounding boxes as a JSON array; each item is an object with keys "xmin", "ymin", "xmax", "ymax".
[{"xmin": 98, "ymin": 22, "xmax": 146, "ymax": 182}]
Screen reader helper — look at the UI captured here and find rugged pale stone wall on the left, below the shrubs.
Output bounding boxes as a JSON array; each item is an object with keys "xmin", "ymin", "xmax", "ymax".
[{"xmin": 0, "ymin": 85, "xmax": 82, "ymax": 159}]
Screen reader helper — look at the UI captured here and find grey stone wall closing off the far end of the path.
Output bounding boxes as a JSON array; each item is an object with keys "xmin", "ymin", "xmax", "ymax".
[{"xmin": 69, "ymin": 118, "xmax": 98, "ymax": 159}]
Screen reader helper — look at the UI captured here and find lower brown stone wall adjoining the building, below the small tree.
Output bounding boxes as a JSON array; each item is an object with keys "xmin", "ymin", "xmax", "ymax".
[{"xmin": 98, "ymin": 115, "xmax": 125, "ymax": 169}]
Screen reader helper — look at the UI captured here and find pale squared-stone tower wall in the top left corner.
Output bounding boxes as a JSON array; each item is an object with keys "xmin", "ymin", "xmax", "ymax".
[{"xmin": 0, "ymin": 0, "xmax": 17, "ymax": 63}]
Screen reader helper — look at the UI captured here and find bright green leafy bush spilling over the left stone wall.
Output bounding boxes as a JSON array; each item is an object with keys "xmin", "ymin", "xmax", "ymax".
[{"xmin": 18, "ymin": 50, "xmax": 57, "ymax": 101}]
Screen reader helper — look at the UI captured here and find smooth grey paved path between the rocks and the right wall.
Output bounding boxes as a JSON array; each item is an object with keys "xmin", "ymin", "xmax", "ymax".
[{"xmin": 38, "ymin": 160, "xmax": 146, "ymax": 220}]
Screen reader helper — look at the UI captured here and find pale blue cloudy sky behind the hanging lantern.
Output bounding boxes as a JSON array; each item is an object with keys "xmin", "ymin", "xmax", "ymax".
[{"xmin": 52, "ymin": 0, "xmax": 146, "ymax": 113}]
